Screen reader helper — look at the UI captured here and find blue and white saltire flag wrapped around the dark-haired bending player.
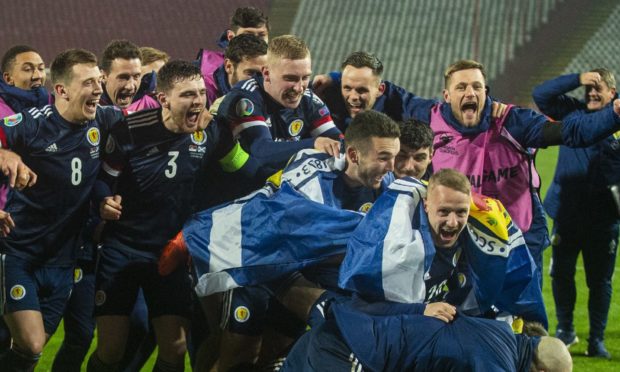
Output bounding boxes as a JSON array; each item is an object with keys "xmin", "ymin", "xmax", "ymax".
[{"xmin": 183, "ymin": 150, "xmax": 363, "ymax": 296}]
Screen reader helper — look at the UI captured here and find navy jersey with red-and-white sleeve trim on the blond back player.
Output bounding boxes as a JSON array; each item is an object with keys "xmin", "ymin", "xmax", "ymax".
[{"xmin": 217, "ymin": 76, "xmax": 341, "ymax": 171}]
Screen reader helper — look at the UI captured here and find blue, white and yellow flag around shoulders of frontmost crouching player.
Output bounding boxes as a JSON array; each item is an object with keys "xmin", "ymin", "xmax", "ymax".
[{"xmin": 339, "ymin": 178, "xmax": 547, "ymax": 326}]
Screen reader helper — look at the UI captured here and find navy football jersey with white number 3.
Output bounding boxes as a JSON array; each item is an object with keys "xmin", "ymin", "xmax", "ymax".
[{"xmin": 101, "ymin": 109, "xmax": 224, "ymax": 255}]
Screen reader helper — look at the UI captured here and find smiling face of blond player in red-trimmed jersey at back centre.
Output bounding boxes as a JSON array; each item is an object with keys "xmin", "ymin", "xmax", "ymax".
[{"xmin": 263, "ymin": 56, "xmax": 312, "ymax": 109}]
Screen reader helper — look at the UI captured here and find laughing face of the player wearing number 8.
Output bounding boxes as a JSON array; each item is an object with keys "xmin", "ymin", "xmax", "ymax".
[{"xmin": 54, "ymin": 63, "xmax": 103, "ymax": 123}]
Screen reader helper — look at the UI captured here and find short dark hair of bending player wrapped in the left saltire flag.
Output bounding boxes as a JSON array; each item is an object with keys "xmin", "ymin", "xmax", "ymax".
[{"xmin": 344, "ymin": 110, "xmax": 400, "ymax": 151}]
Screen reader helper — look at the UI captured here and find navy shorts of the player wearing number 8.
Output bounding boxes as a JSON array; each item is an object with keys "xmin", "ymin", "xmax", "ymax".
[{"xmin": 0, "ymin": 254, "xmax": 74, "ymax": 335}]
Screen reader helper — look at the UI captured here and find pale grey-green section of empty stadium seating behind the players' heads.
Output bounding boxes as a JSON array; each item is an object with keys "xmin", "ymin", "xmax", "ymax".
[{"xmin": 292, "ymin": 0, "xmax": 562, "ymax": 97}]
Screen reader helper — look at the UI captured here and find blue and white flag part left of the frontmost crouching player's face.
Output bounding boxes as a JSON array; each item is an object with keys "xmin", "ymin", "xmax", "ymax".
[{"xmin": 338, "ymin": 177, "xmax": 435, "ymax": 303}]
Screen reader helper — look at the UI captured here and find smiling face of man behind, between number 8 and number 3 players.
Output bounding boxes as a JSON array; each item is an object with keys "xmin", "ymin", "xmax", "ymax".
[{"xmin": 103, "ymin": 58, "xmax": 142, "ymax": 108}]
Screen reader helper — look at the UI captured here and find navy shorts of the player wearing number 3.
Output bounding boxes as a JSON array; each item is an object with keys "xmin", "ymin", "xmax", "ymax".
[{"xmin": 95, "ymin": 245, "xmax": 192, "ymax": 319}]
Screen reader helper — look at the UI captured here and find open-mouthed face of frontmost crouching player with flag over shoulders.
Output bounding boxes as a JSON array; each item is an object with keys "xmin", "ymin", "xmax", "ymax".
[{"xmin": 424, "ymin": 185, "xmax": 471, "ymax": 248}]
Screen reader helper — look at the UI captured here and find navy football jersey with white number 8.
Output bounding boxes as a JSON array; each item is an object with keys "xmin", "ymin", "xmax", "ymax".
[{"xmin": 0, "ymin": 105, "xmax": 123, "ymax": 266}]
